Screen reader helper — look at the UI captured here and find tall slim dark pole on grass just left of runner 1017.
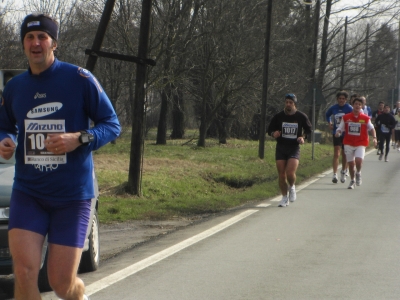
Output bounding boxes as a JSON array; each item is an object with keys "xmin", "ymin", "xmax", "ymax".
[{"xmin": 258, "ymin": 0, "xmax": 272, "ymax": 159}]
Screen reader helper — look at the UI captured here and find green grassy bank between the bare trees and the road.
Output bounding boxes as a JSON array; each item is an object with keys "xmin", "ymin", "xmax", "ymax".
[{"xmin": 94, "ymin": 133, "xmax": 333, "ymax": 223}]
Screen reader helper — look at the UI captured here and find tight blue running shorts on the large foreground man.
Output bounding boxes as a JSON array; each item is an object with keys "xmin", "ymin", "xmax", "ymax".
[{"xmin": 8, "ymin": 189, "xmax": 91, "ymax": 248}]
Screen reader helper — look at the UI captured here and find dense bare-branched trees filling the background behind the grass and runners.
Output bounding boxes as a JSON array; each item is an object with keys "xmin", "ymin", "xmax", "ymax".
[{"xmin": 0, "ymin": 0, "xmax": 400, "ymax": 144}]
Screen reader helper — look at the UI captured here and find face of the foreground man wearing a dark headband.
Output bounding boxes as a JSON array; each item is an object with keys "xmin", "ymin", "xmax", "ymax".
[{"xmin": 24, "ymin": 31, "xmax": 56, "ymax": 71}]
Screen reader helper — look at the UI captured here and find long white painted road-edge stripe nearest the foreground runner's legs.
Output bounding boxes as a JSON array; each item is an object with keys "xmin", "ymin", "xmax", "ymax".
[{"xmin": 85, "ymin": 209, "xmax": 258, "ymax": 295}]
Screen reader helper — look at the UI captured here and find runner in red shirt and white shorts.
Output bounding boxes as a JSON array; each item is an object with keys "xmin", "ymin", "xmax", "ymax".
[{"xmin": 335, "ymin": 98, "xmax": 377, "ymax": 189}]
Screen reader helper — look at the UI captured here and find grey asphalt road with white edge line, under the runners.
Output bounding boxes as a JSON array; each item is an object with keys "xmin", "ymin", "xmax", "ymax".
[{"xmin": 3, "ymin": 146, "xmax": 400, "ymax": 300}]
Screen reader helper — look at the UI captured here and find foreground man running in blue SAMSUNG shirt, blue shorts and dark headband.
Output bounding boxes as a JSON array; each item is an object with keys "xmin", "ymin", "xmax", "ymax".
[{"xmin": 0, "ymin": 14, "xmax": 120, "ymax": 300}]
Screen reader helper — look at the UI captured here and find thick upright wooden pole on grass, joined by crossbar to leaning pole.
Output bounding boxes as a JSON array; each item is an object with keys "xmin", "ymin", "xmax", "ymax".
[{"xmin": 126, "ymin": 0, "xmax": 152, "ymax": 196}]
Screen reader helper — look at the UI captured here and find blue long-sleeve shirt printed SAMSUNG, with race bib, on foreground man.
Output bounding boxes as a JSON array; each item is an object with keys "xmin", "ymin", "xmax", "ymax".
[{"xmin": 0, "ymin": 59, "xmax": 120, "ymax": 201}]
